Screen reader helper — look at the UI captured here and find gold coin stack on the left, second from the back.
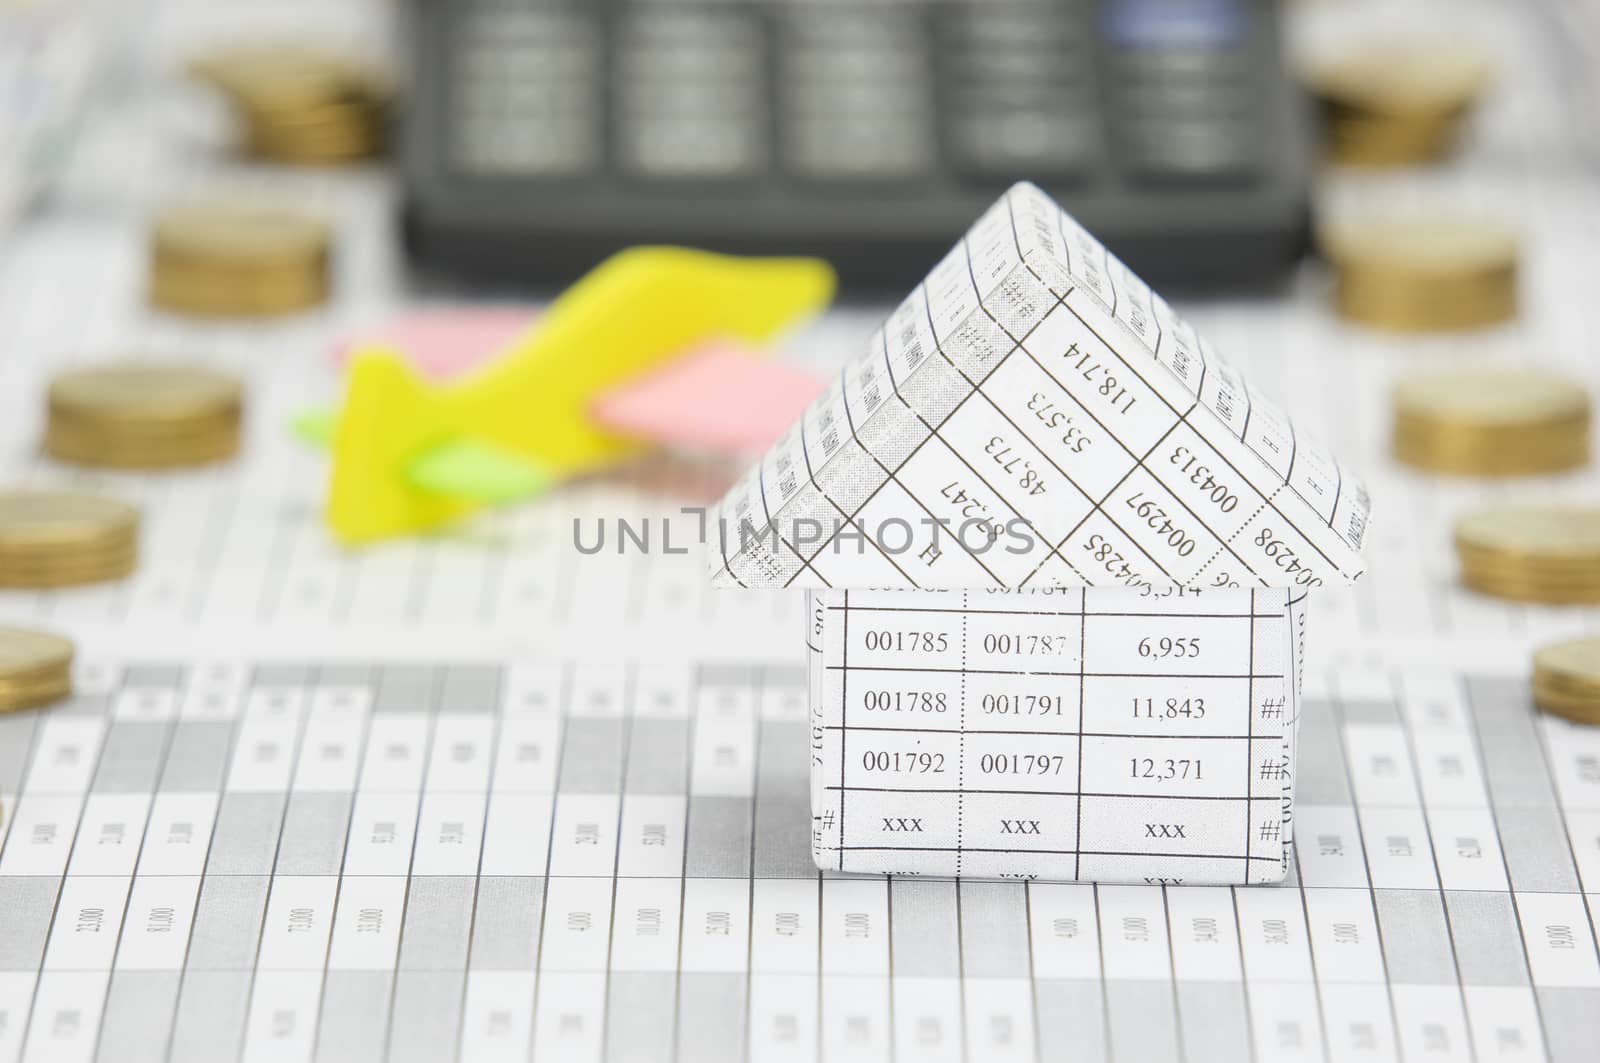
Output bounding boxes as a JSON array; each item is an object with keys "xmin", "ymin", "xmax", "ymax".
[{"xmin": 150, "ymin": 203, "xmax": 328, "ymax": 317}]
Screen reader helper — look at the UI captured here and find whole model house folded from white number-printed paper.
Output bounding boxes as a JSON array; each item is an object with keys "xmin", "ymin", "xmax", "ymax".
[{"xmin": 712, "ymin": 184, "xmax": 1368, "ymax": 884}]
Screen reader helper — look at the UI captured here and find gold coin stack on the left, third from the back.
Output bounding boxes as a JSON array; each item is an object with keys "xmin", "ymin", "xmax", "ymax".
[{"xmin": 45, "ymin": 363, "xmax": 243, "ymax": 469}]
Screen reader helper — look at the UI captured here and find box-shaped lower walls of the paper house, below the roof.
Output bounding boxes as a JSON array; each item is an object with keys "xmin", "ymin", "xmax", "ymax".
[{"xmin": 808, "ymin": 589, "xmax": 1306, "ymax": 885}]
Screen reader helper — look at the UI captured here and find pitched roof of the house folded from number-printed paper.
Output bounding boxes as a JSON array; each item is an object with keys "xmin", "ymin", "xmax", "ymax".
[{"xmin": 710, "ymin": 184, "xmax": 1370, "ymax": 592}]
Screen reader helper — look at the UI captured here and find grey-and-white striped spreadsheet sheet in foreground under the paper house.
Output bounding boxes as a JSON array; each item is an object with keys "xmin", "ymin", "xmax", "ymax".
[{"xmin": 0, "ymin": 660, "xmax": 1600, "ymax": 1060}]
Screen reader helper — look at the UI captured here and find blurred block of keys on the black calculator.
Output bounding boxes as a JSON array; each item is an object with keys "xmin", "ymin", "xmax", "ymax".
[{"xmin": 451, "ymin": 0, "xmax": 1261, "ymax": 184}]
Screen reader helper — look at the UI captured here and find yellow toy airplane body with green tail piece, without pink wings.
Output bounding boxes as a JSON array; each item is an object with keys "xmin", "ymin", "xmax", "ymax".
[{"xmin": 296, "ymin": 247, "xmax": 834, "ymax": 543}]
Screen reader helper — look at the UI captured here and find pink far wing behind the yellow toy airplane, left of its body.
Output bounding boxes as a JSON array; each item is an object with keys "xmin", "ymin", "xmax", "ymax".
[{"xmin": 333, "ymin": 304, "xmax": 534, "ymax": 379}]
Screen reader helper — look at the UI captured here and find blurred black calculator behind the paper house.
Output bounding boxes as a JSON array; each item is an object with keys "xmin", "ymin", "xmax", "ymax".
[{"xmin": 400, "ymin": 0, "xmax": 1310, "ymax": 290}]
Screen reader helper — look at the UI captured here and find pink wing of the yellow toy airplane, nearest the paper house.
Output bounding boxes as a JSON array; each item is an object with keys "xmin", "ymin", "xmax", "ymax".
[{"xmin": 589, "ymin": 341, "xmax": 824, "ymax": 451}]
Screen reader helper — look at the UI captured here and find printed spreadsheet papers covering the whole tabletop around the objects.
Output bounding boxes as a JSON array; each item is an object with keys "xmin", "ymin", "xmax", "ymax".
[{"xmin": 0, "ymin": 0, "xmax": 1600, "ymax": 1063}]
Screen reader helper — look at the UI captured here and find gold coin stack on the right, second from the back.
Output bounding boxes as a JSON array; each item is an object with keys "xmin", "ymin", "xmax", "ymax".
[{"xmin": 1322, "ymin": 218, "xmax": 1517, "ymax": 331}]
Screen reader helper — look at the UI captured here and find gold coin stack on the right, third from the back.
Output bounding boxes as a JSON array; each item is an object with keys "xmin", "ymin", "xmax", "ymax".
[{"xmin": 1394, "ymin": 368, "xmax": 1590, "ymax": 475}]
